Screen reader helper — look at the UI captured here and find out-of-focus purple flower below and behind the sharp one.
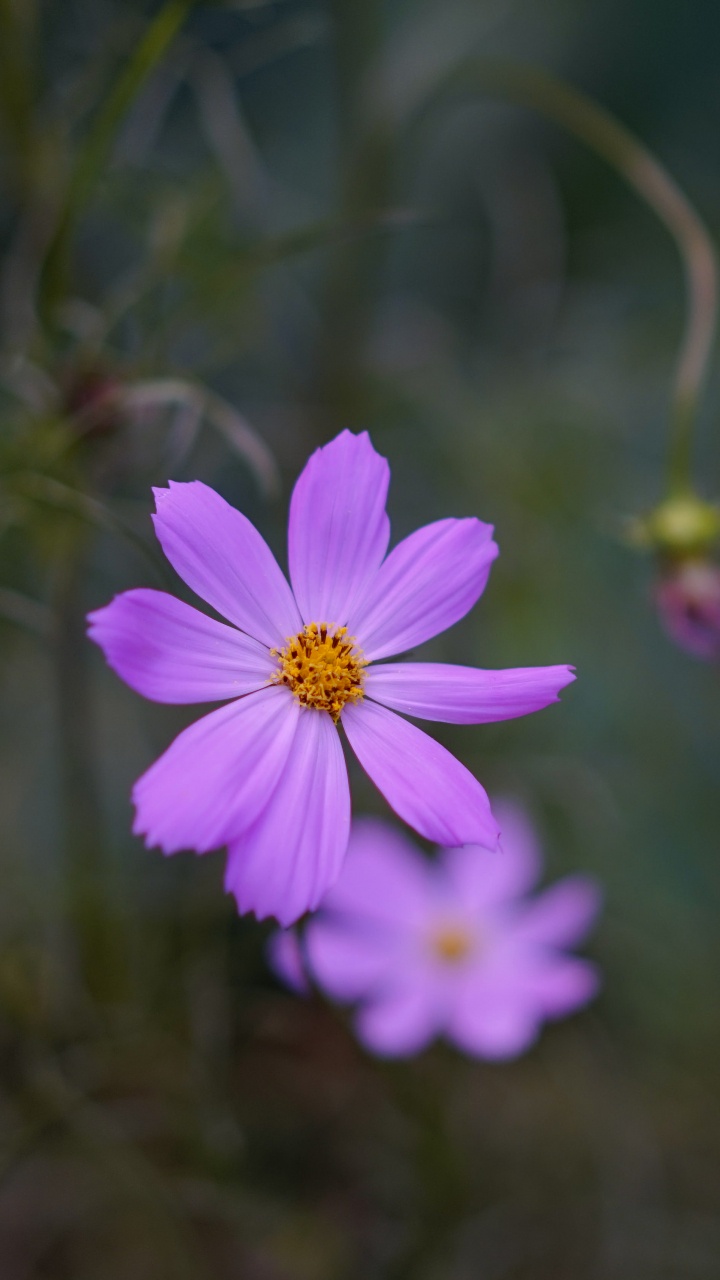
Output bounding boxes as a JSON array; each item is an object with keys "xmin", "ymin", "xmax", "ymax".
[{"xmin": 269, "ymin": 803, "xmax": 600, "ymax": 1059}]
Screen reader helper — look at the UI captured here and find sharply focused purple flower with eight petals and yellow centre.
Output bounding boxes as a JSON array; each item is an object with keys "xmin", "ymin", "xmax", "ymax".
[{"xmin": 90, "ymin": 431, "xmax": 574, "ymax": 924}]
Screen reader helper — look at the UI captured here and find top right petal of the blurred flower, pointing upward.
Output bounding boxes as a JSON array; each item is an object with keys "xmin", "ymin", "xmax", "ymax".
[{"xmin": 441, "ymin": 800, "xmax": 542, "ymax": 913}]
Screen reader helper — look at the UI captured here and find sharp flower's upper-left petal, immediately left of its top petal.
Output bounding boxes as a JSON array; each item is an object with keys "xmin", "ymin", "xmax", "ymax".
[{"xmin": 152, "ymin": 480, "xmax": 302, "ymax": 649}]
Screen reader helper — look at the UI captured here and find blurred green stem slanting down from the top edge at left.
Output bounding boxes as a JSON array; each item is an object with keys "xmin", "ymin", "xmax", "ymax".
[{"xmin": 41, "ymin": 0, "xmax": 196, "ymax": 310}]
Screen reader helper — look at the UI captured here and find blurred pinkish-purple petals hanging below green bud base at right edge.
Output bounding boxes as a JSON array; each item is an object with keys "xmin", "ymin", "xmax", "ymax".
[{"xmin": 655, "ymin": 559, "xmax": 720, "ymax": 660}]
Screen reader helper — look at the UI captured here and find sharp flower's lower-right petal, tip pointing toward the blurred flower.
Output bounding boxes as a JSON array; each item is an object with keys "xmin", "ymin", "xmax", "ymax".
[{"xmin": 342, "ymin": 699, "xmax": 500, "ymax": 849}]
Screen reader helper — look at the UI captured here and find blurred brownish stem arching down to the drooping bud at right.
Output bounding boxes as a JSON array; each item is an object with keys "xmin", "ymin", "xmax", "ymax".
[{"xmin": 422, "ymin": 59, "xmax": 717, "ymax": 494}]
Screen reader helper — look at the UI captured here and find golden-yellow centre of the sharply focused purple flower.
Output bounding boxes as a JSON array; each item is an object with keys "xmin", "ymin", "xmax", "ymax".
[{"xmin": 272, "ymin": 622, "xmax": 368, "ymax": 723}]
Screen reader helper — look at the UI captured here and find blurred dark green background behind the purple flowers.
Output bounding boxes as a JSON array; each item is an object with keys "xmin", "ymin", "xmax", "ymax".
[{"xmin": 0, "ymin": 0, "xmax": 720, "ymax": 1280}]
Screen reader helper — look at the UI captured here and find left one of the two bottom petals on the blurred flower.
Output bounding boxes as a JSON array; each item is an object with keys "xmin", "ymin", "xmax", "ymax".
[{"xmin": 355, "ymin": 980, "xmax": 439, "ymax": 1057}]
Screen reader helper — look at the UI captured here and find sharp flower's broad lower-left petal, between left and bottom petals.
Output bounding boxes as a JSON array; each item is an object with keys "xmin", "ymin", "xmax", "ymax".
[{"xmin": 133, "ymin": 685, "xmax": 299, "ymax": 854}]
